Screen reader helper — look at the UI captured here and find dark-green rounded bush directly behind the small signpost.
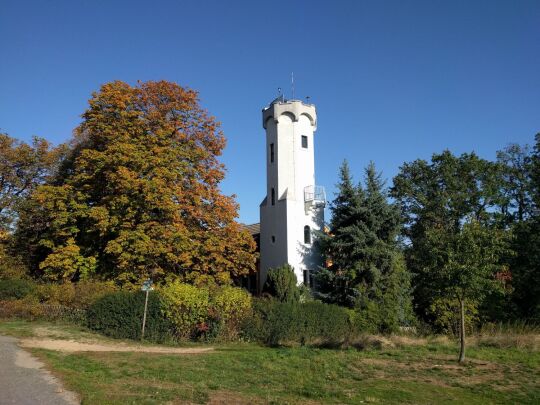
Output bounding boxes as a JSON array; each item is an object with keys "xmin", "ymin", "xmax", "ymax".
[{"xmin": 87, "ymin": 291, "xmax": 173, "ymax": 343}]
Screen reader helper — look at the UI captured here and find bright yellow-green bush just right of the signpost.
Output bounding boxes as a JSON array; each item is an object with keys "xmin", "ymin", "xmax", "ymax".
[{"xmin": 160, "ymin": 282, "xmax": 210, "ymax": 339}]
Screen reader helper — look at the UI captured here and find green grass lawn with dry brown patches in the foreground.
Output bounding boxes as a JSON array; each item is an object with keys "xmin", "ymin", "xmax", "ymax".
[{"xmin": 0, "ymin": 322, "xmax": 540, "ymax": 404}]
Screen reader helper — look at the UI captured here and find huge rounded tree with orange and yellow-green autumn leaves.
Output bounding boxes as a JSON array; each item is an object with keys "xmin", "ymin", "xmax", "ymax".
[{"xmin": 19, "ymin": 81, "xmax": 255, "ymax": 284}]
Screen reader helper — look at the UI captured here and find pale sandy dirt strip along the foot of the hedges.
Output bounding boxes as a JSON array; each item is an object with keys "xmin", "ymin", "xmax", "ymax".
[{"xmin": 19, "ymin": 338, "xmax": 214, "ymax": 354}]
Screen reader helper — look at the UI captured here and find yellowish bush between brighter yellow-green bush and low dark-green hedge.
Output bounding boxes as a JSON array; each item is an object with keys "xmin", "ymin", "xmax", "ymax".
[{"xmin": 207, "ymin": 286, "xmax": 252, "ymax": 340}]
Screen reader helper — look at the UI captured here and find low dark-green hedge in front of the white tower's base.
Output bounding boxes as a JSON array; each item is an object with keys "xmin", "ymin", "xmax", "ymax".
[{"xmin": 244, "ymin": 299, "xmax": 354, "ymax": 346}]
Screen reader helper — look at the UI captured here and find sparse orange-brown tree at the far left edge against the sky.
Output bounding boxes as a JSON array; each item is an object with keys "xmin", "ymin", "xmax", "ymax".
[{"xmin": 0, "ymin": 133, "xmax": 63, "ymax": 232}]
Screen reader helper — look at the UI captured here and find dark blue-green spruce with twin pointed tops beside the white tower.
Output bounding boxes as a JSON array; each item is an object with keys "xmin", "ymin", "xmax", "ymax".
[{"xmin": 318, "ymin": 162, "xmax": 411, "ymax": 331}]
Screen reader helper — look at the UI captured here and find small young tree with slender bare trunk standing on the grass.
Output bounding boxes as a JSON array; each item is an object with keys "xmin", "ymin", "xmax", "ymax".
[{"xmin": 426, "ymin": 219, "xmax": 509, "ymax": 362}]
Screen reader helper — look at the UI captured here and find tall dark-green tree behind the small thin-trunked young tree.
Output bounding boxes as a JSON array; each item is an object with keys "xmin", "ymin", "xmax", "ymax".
[{"xmin": 391, "ymin": 151, "xmax": 501, "ymax": 322}]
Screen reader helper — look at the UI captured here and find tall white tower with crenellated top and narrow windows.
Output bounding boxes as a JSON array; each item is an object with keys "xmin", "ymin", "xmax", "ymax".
[{"xmin": 260, "ymin": 97, "xmax": 326, "ymax": 287}]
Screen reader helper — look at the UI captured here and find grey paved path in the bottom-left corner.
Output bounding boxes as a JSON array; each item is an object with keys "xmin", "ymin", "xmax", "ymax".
[{"xmin": 0, "ymin": 336, "xmax": 79, "ymax": 405}]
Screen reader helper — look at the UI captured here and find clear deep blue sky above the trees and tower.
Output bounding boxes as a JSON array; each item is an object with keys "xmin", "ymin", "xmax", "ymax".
[{"xmin": 0, "ymin": 0, "xmax": 540, "ymax": 222}]
